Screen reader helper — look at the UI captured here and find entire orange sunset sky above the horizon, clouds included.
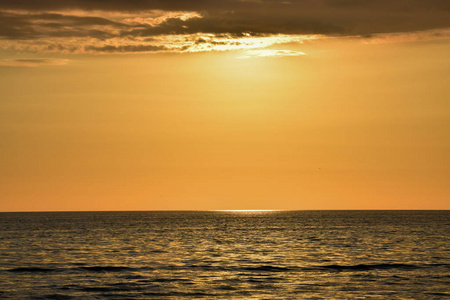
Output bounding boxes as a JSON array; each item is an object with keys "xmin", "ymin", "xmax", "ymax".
[{"xmin": 0, "ymin": 0, "xmax": 450, "ymax": 211}]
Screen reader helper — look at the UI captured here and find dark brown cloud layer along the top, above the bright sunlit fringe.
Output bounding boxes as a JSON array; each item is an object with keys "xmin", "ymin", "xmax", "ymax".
[{"xmin": 0, "ymin": 0, "xmax": 450, "ymax": 52}]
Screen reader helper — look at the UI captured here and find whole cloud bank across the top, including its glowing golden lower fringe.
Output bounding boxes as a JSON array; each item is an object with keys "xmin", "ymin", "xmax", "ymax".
[{"xmin": 0, "ymin": 0, "xmax": 450, "ymax": 53}]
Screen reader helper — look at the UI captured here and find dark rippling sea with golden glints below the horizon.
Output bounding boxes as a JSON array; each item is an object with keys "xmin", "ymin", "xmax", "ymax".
[{"xmin": 0, "ymin": 211, "xmax": 450, "ymax": 299}]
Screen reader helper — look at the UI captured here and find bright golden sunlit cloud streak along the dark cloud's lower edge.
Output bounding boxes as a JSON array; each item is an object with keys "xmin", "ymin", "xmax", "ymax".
[{"xmin": 2, "ymin": 33, "xmax": 316, "ymax": 54}]
